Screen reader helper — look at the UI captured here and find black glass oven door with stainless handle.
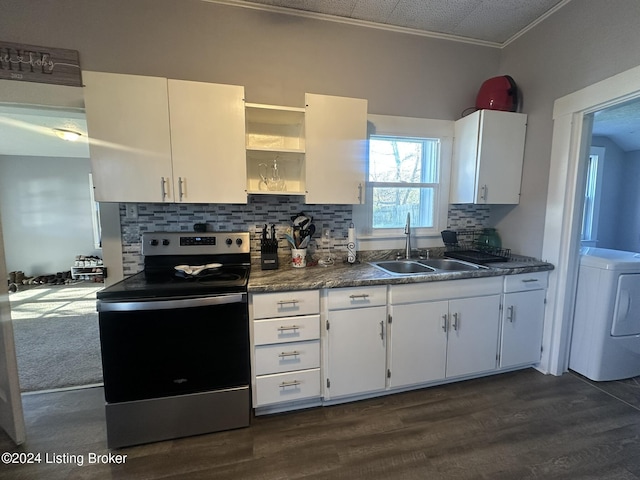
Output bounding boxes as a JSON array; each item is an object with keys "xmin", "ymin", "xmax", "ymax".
[{"xmin": 98, "ymin": 293, "xmax": 250, "ymax": 403}]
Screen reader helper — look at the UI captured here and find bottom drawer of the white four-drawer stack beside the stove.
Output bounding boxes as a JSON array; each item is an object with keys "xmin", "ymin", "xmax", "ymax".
[{"xmin": 254, "ymin": 368, "xmax": 320, "ymax": 407}]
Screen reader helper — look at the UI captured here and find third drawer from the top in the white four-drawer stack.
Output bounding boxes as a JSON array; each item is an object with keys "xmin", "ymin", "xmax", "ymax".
[{"xmin": 255, "ymin": 340, "xmax": 320, "ymax": 375}]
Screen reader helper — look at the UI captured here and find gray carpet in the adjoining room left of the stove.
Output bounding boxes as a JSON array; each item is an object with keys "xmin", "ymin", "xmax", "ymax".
[{"xmin": 9, "ymin": 282, "xmax": 102, "ymax": 392}]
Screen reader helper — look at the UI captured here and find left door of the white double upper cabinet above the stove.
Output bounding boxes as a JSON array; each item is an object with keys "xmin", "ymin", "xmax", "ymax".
[{"xmin": 82, "ymin": 72, "xmax": 174, "ymax": 202}]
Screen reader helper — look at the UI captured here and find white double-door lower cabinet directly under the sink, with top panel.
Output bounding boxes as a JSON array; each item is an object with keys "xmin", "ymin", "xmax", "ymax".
[{"xmin": 389, "ymin": 277, "xmax": 502, "ymax": 388}]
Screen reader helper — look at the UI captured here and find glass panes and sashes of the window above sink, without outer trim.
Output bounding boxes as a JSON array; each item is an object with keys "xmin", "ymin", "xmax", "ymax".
[{"xmin": 368, "ymin": 135, "xmax": 440, "ymax": 230}]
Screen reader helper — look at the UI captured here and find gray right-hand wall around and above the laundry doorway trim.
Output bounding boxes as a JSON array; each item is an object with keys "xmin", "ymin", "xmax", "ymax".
[{"xmin": 492, "ymin": 0, "xmax": 640, "ymax": 256}]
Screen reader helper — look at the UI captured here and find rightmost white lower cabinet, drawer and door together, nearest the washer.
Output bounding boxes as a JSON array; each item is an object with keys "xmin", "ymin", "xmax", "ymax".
[{"xmin": 500, "ymin": 272, "xmax": 548, "ymax": 368}]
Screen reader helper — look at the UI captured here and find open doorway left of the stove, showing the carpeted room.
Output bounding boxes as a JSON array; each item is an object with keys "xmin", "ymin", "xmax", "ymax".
[{"xmin": 0, "ymin": 104, "xmax": 102, "ymax": 393}]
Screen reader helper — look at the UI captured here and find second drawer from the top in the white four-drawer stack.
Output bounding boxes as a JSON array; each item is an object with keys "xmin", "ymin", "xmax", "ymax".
[{"xmin": 253, "ymin": 315, "xmax": 320, "ymax": 345}]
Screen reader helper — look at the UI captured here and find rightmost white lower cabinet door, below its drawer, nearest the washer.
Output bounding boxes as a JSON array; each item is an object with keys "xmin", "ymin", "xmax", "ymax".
[{"xmin": 500, "ymin": 290, "xmax": 546, "ymax": 368}]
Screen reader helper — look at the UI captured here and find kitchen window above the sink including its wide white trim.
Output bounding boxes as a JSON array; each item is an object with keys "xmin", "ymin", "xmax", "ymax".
[{"xmin": 353, "ymin": 114, "xmax": 454, "ymax": 250}]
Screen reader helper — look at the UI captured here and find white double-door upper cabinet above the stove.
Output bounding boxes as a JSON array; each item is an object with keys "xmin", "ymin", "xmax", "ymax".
[{"xmin": 83, "ymin": 72, "xmax": 246, "ymax": 203}]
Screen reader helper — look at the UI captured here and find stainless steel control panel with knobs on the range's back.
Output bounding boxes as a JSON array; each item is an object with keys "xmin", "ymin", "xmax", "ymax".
[{"xmin": 142, "ymin": 232, "xmax": 251, "ymax": 255}]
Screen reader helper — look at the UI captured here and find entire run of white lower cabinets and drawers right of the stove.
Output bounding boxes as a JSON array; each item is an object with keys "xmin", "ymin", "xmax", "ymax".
[{"xmin": 250, "ymin": 272, "xmax": 548, "ymax": 414}]
